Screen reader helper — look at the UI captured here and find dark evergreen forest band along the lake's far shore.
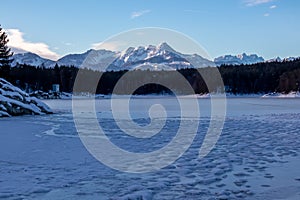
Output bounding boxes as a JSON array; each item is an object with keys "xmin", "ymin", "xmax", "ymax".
[{"xmin": 0, "ymin": 59, "xmax": 300, "ymax": 94}]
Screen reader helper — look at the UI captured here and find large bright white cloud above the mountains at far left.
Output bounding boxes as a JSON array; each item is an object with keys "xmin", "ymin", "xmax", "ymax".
[{"xmin": 5, "ymin": 29, "xmax": 59, "ymax": 60}]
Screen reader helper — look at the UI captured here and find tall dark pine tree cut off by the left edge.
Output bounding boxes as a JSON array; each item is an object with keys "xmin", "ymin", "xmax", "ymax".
[{"xmin": 0, "ymin": 25, "xmax": 13, "ymax": 79}]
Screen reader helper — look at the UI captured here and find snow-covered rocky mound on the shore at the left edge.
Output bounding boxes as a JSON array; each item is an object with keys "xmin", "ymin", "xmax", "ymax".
[{"xmin": 0, "ymin": 78, "xmax": 52, "ymax": 117}]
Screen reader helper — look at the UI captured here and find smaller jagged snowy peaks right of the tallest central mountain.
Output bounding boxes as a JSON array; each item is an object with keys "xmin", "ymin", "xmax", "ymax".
[{"xmin": 214, "ymin": 53, "xmax": 265, "ymax": 66}]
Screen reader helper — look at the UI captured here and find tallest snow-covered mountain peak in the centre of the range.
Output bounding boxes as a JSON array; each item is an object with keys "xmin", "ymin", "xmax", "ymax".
[{"xmin": 108, "ymin": 43, "xmax": 215, "ymax": 71}]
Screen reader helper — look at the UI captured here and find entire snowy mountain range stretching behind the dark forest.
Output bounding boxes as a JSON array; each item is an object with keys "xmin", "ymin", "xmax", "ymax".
[{"xmin": 12, "ymin": 43, "xmax": 295, "ymax": 71}]
